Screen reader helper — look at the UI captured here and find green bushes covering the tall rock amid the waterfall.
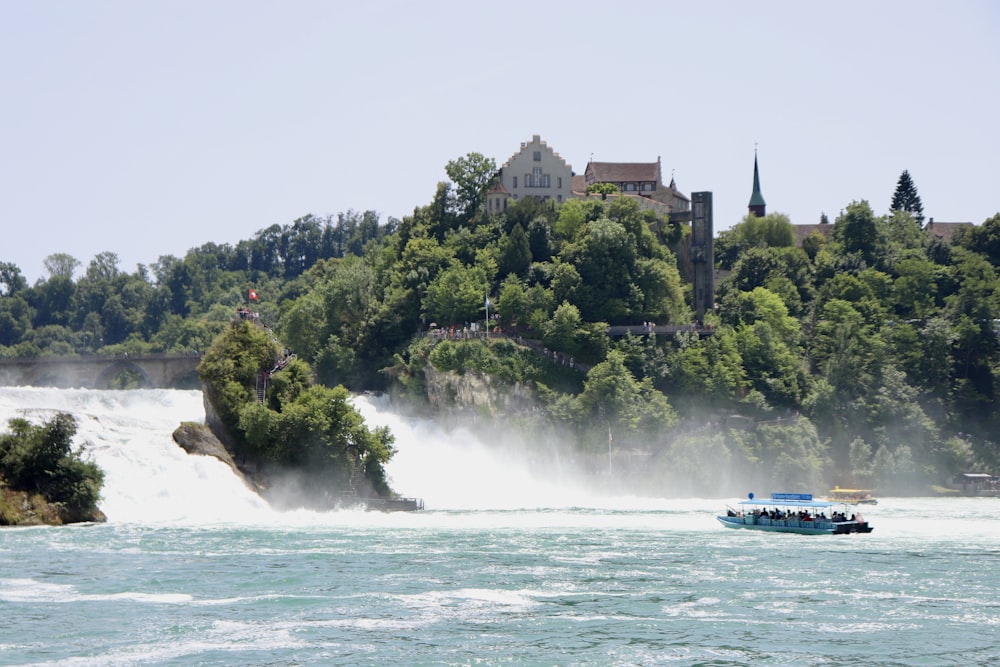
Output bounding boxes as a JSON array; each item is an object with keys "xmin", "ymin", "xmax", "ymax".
[{"xmin": 198, "ymin": 320, "xmax": 394, "ymax": 505}]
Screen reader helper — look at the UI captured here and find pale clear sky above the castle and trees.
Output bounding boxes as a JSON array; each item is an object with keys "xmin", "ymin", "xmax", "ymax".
[{"xmin": 0, "ymin": 0, "xmax": 1000, "ymax": 284}]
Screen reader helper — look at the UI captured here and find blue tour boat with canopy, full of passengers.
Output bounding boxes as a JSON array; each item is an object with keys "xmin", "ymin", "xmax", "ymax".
[{"xmin": 716, "ymin": 493, "xmax": 873, "ymax": 535}]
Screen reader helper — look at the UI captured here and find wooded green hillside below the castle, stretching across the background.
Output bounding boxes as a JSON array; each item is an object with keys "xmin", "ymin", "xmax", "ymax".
[{"xmin": 0, "ymin": 160, "xmax": 1000, "ymax": 493}]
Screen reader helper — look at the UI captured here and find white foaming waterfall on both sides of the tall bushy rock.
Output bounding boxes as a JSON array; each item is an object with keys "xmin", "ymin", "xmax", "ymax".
[{"xmin": 0, "ymin": 387, "xmax": 711, "ymax": 525}]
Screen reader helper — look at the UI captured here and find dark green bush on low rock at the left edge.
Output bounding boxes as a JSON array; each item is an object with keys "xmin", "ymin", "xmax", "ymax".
[{"xmin": 0, "ymin": 413, "xmax": 105, "ymax": 525}]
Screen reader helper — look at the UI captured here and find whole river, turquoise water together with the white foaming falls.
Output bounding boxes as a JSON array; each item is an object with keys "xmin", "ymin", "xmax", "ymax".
[{"xmin": 0, "ymin": 388, "xmax": 1000, "ymax": 667}]
